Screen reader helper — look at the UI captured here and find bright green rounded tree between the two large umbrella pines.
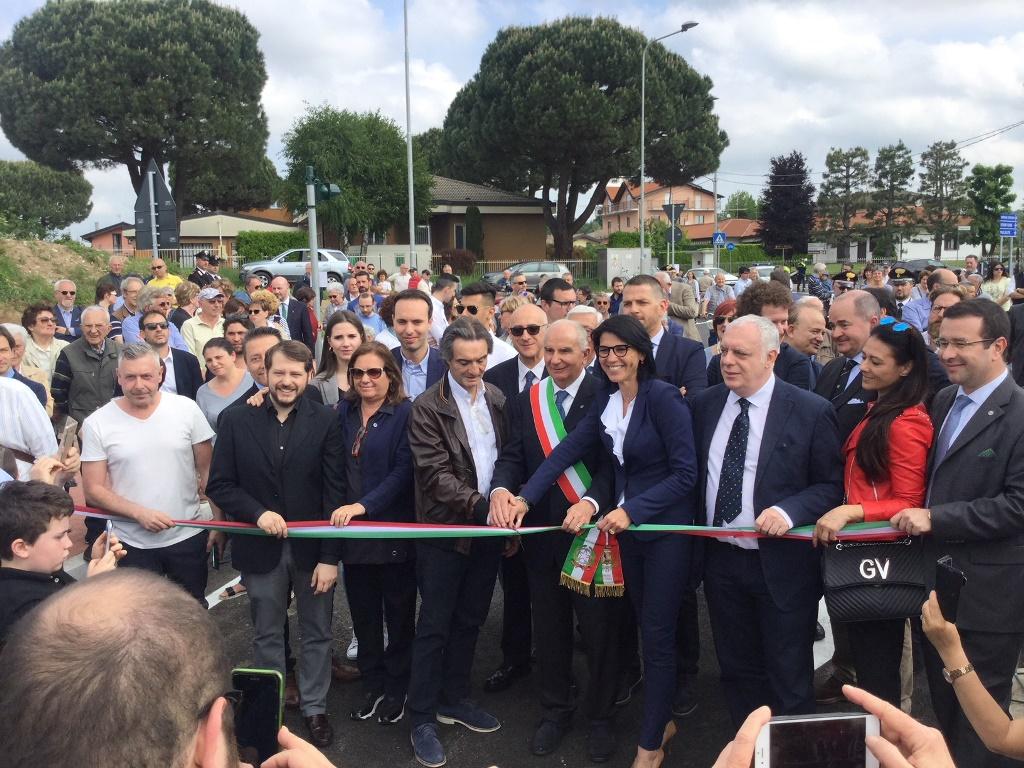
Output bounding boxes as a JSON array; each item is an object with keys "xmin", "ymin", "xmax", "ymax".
[{"xmin": 283, "ymin": 106, "xmax": 430, "ymax": 246}]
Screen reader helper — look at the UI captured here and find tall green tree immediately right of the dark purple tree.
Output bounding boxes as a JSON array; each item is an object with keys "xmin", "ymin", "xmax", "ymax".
[{"xmin": 818, "ymin": 146, "xmax": 870, "ymax": 261}]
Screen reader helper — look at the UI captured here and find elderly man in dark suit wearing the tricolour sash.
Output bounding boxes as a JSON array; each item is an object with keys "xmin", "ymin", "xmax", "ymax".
[{"xmin": 484, "ymin": 319, "xmax": 622, "ymax": 762}]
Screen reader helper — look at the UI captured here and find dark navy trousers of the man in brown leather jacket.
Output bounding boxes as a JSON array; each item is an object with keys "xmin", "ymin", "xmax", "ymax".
[{"xmin": 407, "ymin": 539, "xmax": 505, "ymax": 728}]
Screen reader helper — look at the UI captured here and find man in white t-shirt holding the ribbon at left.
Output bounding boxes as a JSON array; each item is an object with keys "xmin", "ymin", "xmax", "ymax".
[{"xmin": 82, "ymin": 344, "xmax": 223, "ymax": 602}]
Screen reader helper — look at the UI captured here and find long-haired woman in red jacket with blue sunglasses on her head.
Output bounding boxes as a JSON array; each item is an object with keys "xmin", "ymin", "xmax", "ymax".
[{"xmin": 814, "ymin": 317, "xmax": 933, "ymax": 707}]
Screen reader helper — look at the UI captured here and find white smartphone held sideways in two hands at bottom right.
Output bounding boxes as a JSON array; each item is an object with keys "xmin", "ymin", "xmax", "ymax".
[{"xmin": 754, "ymin": 713, "xmax": 879, "ymax": 768}]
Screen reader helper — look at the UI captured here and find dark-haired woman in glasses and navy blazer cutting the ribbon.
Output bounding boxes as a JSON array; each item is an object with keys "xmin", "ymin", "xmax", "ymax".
[{"xmin": 520, "ymin": 315, "xmax": 697, "ymax": 768}]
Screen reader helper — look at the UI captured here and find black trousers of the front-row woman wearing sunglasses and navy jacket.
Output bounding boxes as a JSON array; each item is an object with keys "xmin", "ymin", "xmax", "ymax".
[{"xmin": 342, "ymin": 560, "xmax": 416, "ymax": 697}]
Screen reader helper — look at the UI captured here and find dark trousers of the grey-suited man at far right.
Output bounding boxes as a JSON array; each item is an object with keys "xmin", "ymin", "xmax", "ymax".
[{"xmin": 923, "ymin": 630, "xmax": 1024, "ymax": 768}]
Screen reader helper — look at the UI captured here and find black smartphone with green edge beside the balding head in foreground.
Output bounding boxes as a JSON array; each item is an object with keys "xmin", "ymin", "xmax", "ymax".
[{"xmin": 231, "ymin": 669, "xmax": 285, "ymax": 765}]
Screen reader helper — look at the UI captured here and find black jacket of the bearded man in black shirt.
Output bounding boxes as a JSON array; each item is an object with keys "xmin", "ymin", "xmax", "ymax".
[{"xmin": 206, "ymin": 397, "xmax": 345, "ymax": 573}]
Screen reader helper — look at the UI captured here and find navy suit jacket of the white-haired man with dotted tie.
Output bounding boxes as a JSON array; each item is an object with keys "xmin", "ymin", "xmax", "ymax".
[{"xmin": 694, "ymin": 377, "xmax": 843, "ymax": 610}]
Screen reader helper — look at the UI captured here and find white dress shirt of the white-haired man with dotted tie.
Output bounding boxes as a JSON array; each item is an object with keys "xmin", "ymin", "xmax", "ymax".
[{"xmin": 705, "ymin": 375, "xmax": 793, "ymax": 549}]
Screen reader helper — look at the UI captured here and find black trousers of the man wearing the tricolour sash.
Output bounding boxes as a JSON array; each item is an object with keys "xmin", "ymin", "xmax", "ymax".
[{"xmin": 524, "ymin": 531, "xmax": 618, "ymax": 726}]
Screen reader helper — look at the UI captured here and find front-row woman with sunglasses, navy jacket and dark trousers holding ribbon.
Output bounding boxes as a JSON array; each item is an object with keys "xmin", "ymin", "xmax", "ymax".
[{"xmin": 329, "ymin": 344, "xmax": 416, "ymax": 723}]
